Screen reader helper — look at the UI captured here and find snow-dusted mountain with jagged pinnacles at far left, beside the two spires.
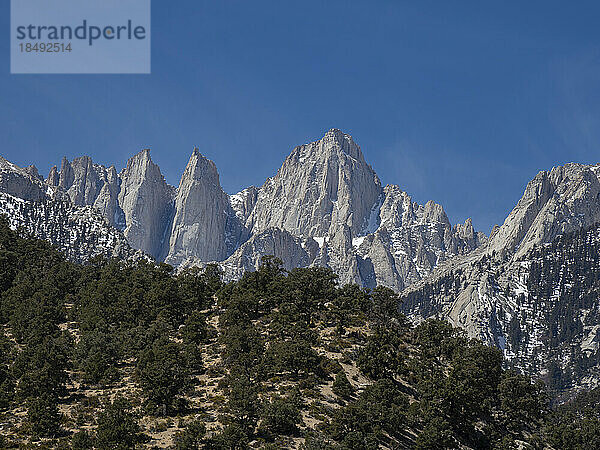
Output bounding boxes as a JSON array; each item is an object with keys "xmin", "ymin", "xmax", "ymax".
[{"xmin": 0, "ymin": 157, "xmax": 137, "ymax": 262}]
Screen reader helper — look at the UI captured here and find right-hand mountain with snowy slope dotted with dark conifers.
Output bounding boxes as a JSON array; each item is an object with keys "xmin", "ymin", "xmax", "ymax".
[{"xmin": 402, "ymin": 164, "xmax": 600, "ymax": 395}]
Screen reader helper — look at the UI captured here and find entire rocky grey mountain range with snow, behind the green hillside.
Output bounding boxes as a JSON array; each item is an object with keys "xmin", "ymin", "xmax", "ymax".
[{"xmin": 0, "ymin": 129, "xmax": 600, "ymax": 398}]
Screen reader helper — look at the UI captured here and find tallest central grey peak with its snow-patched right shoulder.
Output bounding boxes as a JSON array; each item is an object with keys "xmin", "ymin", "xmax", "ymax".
[{"xmin": 223, "ymin": 129, "xmax": 486, "ymax": 290}]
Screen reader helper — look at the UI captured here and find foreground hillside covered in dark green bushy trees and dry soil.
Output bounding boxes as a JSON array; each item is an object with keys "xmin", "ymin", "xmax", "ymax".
[{"xmin": 0, "ymin": 216, "xmax": 600, "ymax": 449}]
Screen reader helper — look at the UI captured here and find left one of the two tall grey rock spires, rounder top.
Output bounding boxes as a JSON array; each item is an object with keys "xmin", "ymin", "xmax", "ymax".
[{"xmin": 117, "ymin": 150, "xmax": 174, "ymax": 259}]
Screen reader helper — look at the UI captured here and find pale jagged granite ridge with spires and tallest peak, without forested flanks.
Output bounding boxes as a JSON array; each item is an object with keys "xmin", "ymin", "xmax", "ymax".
[{"xmin": 0, "ymin": 129, "xmax": 486, "ymax": 290}]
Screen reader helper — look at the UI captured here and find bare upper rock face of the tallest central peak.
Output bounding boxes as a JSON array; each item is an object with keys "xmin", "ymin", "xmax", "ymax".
[{"xmin": 246, "ymin": 130, "xmax": 381, "ymax": 237}]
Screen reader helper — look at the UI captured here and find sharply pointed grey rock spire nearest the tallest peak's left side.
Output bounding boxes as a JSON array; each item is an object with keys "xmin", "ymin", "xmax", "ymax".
[{"xmin": 165, "ymin": 149, "xmax": 235, "ymax": 265}]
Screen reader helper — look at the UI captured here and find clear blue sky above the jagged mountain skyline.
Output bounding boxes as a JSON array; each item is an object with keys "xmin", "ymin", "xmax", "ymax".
[{"xmin": 0, "ymin": 0, "xmax": 600, "ymax": 232}]
